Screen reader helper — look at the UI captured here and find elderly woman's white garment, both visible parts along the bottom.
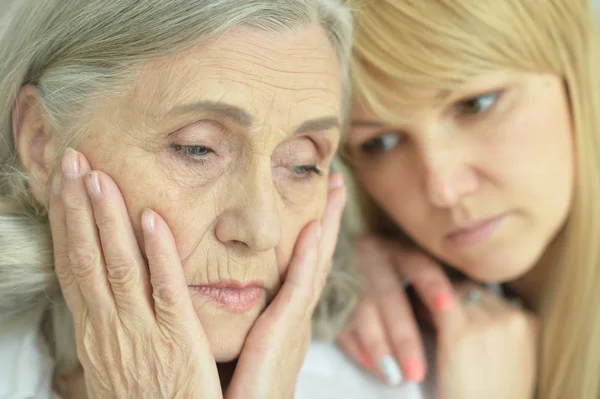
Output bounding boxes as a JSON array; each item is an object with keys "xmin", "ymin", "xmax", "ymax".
[{"xmin": 0, "ymin": 320, "xmax": 431, "ymax": 399}]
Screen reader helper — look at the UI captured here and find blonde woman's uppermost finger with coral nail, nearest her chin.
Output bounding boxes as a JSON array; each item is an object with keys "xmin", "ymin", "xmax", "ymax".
[{"xmin": 392, "ymin": 247, "xmax": 466, "ymax": 331}]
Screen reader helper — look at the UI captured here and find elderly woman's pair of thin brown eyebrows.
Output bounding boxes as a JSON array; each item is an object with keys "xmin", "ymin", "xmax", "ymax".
[{"xmin": 169, "ymin": 100, "xmax": 340, "ymax": 136}]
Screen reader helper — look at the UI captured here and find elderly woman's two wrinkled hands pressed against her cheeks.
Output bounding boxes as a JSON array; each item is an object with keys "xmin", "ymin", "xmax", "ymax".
[{"xmin": 49, "ymin": 149, "xmax": 345, "ymax": 399}]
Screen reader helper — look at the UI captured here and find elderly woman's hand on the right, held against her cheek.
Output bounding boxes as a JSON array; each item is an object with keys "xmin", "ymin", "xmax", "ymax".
[{"xmin": 225, "ymin": 174, "xmax": 346, "ymax": 399}]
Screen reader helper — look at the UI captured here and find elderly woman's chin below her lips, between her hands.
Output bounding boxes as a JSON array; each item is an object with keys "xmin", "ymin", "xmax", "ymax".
[{"xmin": 190, "ymin": 289, "xmax": 266, "ymax": 362}]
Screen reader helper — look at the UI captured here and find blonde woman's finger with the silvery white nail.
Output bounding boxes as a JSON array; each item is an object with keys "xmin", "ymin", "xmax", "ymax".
[{"xmin": 354, "ymin": 299, "xmax": 404, "ymax": 386}]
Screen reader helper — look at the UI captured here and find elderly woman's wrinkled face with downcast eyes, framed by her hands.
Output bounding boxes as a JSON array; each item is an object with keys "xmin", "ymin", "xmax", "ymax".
[{"xmin": 78, "ymin": 26, "xmax": 341, "ymax": 361}]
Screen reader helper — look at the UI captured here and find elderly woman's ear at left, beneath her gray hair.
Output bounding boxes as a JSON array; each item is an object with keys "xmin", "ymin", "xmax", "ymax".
[{"xmin": 12, "ymin": 85, "xmax": 58, "ymax": 204}]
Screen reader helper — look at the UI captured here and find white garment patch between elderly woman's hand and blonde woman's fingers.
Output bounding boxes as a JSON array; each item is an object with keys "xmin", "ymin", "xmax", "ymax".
[{"xmin": 296, "ymin": 342, "xmax": 432, "ymax": 399}]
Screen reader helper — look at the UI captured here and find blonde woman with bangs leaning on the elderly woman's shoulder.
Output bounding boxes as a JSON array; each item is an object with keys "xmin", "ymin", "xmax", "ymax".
[{"xmin": 340, "ymin": 0, "xmax": 600, "ymax": 399}]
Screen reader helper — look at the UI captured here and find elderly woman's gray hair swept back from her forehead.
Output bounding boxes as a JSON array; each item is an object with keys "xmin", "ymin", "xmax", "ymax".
[{"xmin": 0, "ymin": 0, "xmax": 353, "ymax": 373}]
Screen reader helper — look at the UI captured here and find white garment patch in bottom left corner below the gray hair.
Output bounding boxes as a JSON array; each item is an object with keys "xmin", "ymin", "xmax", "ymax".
[{"xmin": 0, "ymin": 318, "xmax": 54, "ymax": 399}]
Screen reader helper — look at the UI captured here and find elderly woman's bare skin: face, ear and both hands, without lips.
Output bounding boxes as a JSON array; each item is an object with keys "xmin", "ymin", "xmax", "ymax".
[{"xmin": 14, "ymin": 25, "xmax": 345, "ymax": 398}]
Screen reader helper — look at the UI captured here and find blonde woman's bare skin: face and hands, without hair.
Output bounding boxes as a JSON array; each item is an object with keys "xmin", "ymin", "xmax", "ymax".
[{"xmin": 339, "ymin": 71, "xmax": 574, "ymax": 398}]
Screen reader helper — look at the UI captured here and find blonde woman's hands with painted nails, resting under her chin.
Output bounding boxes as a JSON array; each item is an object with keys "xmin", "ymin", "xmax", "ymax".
[{"xmin": 338, "ymin": 237, "xmax": 537, "ymax": 399}]
